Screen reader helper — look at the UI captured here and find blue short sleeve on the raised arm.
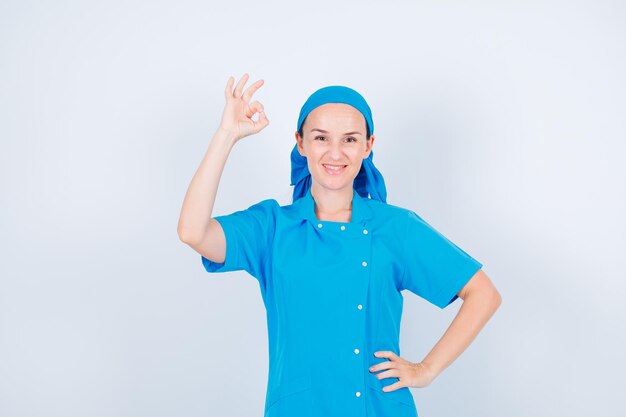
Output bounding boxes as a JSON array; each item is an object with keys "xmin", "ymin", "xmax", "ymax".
[{"xmin": 202, "ymin": 199, "xmax": 280, "ymax": 283}]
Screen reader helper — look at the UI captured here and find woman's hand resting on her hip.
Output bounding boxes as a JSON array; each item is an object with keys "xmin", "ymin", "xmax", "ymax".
[{"xmin": 370, "ymin": 350, "xmax": 436, "ymax": 392}]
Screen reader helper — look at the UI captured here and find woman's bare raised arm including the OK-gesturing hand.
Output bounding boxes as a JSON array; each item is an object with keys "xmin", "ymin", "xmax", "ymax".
[{"xmin": 178, "ymin": 74, "xmax": 269, "ymax": 263}]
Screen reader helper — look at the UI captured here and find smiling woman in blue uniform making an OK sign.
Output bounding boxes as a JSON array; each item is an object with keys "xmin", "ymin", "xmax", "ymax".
[{"xmin": 178, "ymin": 74, "xmax": 501, "ymax": 417}]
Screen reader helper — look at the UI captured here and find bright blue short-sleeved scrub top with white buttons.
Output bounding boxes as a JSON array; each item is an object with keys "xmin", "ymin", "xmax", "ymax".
[{"xmin": 202, "ymin": 190, "xmax": 482, "ymax": 417}]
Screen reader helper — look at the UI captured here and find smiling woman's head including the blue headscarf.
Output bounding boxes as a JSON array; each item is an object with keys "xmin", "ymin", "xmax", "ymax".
[{"xmin": 291, "ymin": 85, "xmax": 387, "ymax": 202}]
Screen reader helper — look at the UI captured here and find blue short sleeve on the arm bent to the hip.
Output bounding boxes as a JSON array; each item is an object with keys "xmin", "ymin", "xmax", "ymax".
[{"xmin": 401, "ymin": 210, "xmax": 482, "ymax": 309}]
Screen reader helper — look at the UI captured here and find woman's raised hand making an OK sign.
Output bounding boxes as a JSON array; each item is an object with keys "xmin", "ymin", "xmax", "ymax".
[{"xmin": 219, "ymin": 73, "xmax": 270, "ymax": 141}]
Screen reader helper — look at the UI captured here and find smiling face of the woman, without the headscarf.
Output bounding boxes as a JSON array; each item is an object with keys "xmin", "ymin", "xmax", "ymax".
[{"xmin": 296, "ymin": 103, "xmax": 374, "ymax": 195}]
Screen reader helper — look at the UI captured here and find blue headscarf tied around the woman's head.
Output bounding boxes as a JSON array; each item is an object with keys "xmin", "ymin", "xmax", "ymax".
[{"xmin": 291, "ymin": 85, "xmax": 387, "ymax": 203}]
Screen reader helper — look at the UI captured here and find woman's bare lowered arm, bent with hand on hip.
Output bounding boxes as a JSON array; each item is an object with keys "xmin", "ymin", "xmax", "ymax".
[{"xmin": 370, "ymin": 269, "xmax": 502, "ymax": 391}]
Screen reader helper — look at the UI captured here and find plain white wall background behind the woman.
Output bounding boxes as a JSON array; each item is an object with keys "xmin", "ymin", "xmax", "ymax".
[{"xmin": 0, "ymin": 1, "xmax": 626, "ymax": 417}]
